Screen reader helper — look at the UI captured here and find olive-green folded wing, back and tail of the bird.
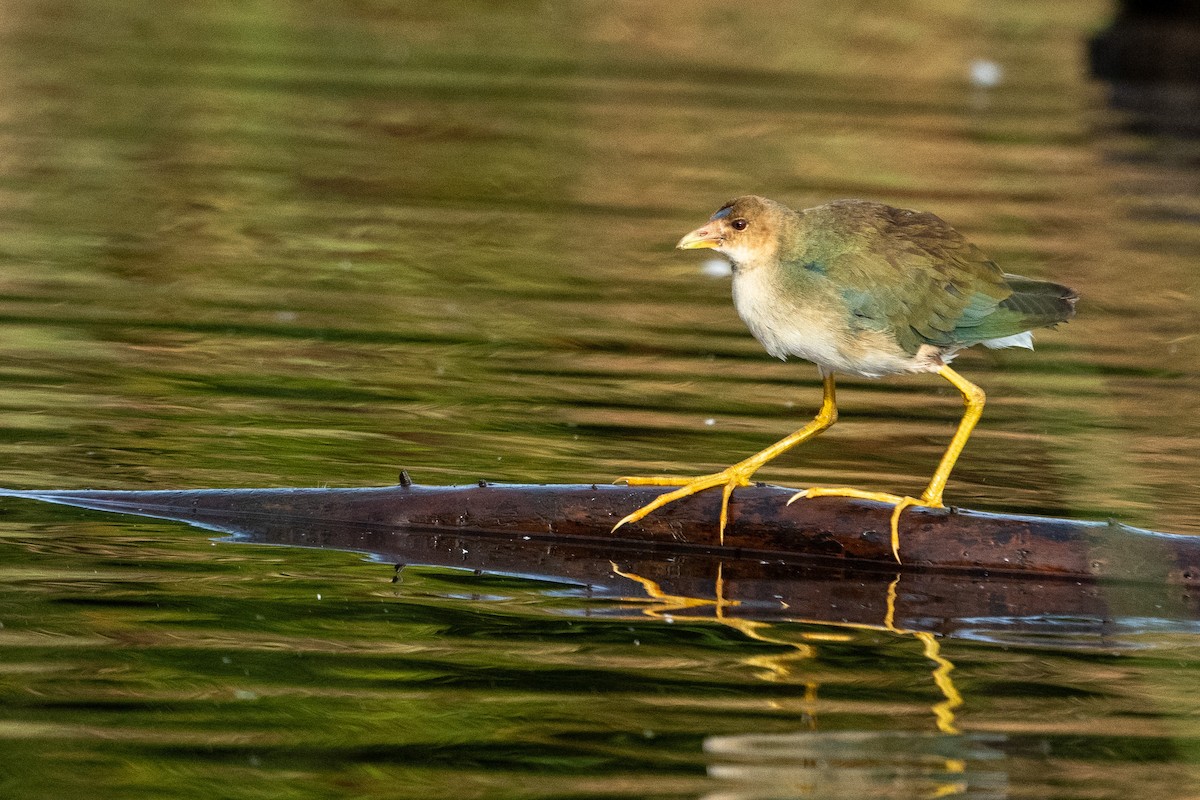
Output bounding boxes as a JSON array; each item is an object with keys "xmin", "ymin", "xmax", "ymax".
[{"xmin": 802, "ymin": 200, "xmax": 1075, "ymax": 354}]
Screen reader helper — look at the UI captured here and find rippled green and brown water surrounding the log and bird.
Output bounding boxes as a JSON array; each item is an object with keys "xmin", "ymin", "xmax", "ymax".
[{"xmin": 0, "ymin": 0, "xmax": 1200, "ymax": 798}]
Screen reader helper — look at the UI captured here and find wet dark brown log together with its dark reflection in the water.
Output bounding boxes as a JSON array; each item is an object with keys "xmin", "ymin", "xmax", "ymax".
[{"xmin": 0, "ymin": 482, "xmax": 1200, "ymax": 640}]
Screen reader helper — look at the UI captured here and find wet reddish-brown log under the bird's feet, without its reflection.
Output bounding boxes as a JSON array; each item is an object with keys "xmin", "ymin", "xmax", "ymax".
[{"xmin": 0, "ymin": 482, "xmax": 1200, "ymax": 587}]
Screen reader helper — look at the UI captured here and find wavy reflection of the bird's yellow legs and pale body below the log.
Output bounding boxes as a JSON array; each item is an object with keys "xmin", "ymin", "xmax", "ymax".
[{"xmin": 612, "ymin": 561, "xmax": 993, "ymax": 798}]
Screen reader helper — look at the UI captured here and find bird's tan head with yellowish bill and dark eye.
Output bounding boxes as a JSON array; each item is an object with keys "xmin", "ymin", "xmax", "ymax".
[{"xmin": 676, "ymin": 194, "xmax": 793, "ymax": 266}]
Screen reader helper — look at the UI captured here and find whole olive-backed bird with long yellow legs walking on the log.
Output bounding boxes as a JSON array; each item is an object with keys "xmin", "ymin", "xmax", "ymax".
[{"xmin": 613, "ymin": 194, "xmax": 1079, "ymax": 563}]
